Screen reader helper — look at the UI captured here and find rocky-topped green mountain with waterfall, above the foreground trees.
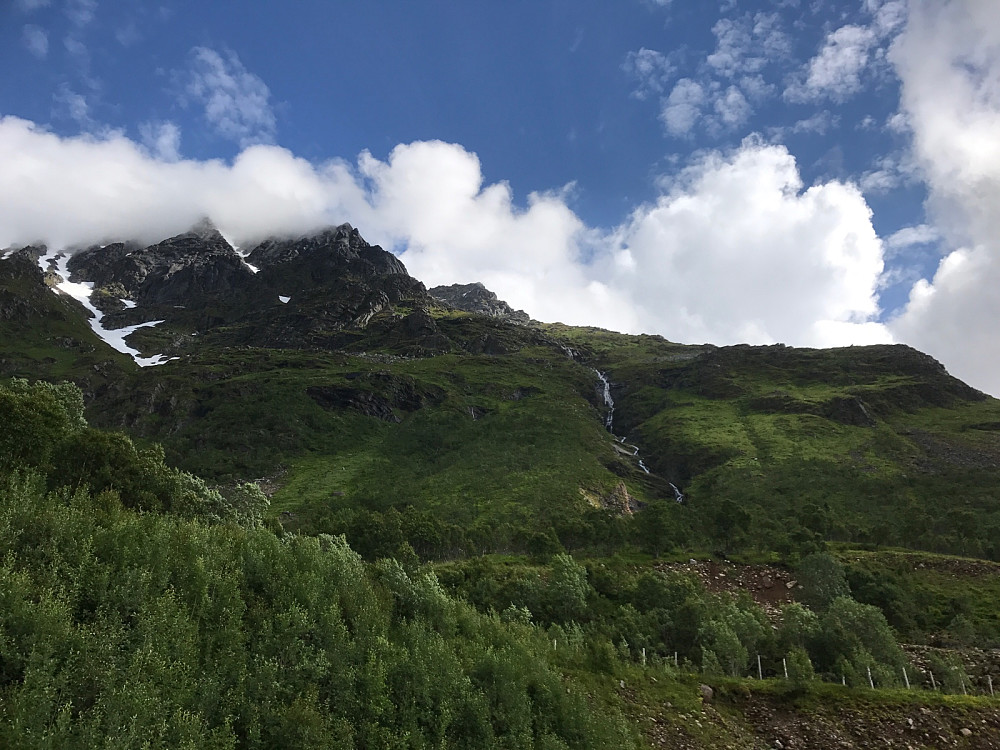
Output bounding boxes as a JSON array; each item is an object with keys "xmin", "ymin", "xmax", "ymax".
[{"xmin": 0, "ymin": 221, "xmax": 1000, "ymax": 557}]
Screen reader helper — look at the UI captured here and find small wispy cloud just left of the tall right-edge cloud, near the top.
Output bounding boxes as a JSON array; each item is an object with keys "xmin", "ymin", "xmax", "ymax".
[{"xmin": 785, "ymin": 24, "xmax": 878, "ymax": 102}]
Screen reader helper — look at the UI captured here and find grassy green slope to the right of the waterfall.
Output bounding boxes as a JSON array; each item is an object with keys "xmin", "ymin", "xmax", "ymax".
[{"xmin": 549, "ymin": 326, "xmax": 1000, "ymax": 557}]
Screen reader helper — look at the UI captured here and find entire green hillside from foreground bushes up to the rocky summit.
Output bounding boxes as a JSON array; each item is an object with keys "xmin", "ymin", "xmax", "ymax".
[{"xmin": 0, "ymin": 232, "xmax": 1000, "ymax": 748}]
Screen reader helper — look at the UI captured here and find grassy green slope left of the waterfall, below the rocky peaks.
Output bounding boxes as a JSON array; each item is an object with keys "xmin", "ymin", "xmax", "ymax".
[{"xmin": 92, "ymin": 332, "xmax": 645, "ymax": 524}]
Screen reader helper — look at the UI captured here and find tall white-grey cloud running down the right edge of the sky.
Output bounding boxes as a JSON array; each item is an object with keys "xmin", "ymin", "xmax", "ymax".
[{"xmin": 890, "ymin": 0, "xmax": 1000, "ymax": 394}]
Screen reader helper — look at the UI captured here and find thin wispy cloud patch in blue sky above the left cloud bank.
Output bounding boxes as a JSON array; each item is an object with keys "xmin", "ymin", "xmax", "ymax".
[{"xmin": 185, "ymin": 47, "xmax": 276, "ymax": 147}]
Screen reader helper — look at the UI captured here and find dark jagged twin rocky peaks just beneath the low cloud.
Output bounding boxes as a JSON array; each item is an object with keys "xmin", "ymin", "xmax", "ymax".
[{"xmin": 68, "ymin": 216, "xmax": 450, "ymax": 350}]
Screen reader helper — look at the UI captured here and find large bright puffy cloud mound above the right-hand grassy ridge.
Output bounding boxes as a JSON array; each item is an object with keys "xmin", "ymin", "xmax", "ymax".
[{"xmin": 615, "ymin": 141, "xmax": 890, "ymax": 346}]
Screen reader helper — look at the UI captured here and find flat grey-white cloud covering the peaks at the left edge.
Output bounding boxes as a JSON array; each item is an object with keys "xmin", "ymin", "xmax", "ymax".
[{"xmin": 0, "ymin": 117, "xmax": 347, "ymax": 247}]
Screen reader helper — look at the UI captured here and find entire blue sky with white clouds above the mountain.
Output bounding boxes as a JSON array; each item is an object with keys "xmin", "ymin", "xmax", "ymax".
[{"xmin": 0, "ymin": 0, "xmax": 1000, "ymax": 395}]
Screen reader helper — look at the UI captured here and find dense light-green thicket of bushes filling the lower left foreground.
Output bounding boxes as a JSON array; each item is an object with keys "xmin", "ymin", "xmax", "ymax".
[{"xmin": 0, "ymin": 383, "xmax": 634, "ymax": 748}]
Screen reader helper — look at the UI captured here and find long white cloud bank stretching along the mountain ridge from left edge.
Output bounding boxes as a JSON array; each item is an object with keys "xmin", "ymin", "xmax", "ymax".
[{"xmin": 0, "ymin": 117, "xmax": 889, "ymax": 346}]
